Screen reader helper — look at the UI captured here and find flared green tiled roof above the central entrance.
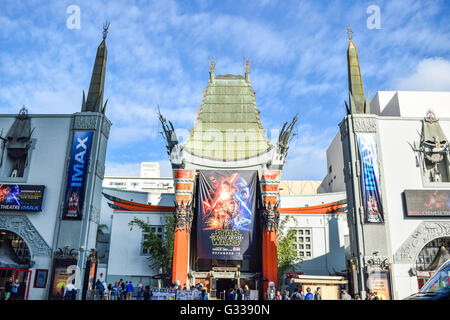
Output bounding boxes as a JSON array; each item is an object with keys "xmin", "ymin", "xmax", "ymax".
[{"xmin": 183, "ymin": 75, "xmax": 272, "ymax": 161}]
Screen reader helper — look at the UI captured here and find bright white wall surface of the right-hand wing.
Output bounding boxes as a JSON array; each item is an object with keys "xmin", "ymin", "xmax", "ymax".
[{"xmin": 378, "ymin": 114, "xmax": 450, "ymax": 299}]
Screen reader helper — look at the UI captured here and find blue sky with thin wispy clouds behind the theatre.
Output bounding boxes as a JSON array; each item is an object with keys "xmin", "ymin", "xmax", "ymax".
[{"xmin": 0, "ymin": 0, "xmax": 450, "ymax": 180}]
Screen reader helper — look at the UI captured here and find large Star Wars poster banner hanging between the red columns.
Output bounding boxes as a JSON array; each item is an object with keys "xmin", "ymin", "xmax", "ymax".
[{"xmin": 197, "ymin": 170, "xmax": 257, "ymax": 260}]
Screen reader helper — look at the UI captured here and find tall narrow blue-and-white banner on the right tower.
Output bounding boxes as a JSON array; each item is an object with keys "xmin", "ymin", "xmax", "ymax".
[{"xmin": 357, "ymin": 133, "xmax": 384, "ymax": 223}]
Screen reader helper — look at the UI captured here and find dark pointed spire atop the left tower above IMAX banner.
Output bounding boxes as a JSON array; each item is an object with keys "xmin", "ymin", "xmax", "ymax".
[{"xmin": 81, "ymin": 22, "xmax": 109, "ymax": 112}]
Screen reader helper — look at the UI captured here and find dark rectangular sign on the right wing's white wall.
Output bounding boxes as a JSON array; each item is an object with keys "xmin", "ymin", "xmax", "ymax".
[{"xmin": 404, "ymin": 190, "xmax": 450, "ymax": 217}]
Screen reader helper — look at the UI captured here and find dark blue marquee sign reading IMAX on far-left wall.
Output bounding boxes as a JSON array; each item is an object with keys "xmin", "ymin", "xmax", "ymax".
[{"xmin": 0, "ymin": 184, "xmax": 45, "ymax": 212}]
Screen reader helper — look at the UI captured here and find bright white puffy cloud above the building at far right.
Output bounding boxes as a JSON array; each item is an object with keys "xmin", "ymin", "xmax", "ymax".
[{"xmin": 393, "ymin": 58, "xmax": 450, "ymax": 91}]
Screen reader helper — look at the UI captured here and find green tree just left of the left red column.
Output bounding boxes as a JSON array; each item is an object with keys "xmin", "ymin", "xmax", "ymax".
[{"xmin": 128, "ymin": 215, "xmax": 175, "ymax": 284}]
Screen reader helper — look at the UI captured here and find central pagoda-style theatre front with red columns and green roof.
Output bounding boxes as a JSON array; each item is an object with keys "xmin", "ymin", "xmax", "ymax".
[{"xmin": 104, "ymin": 60, "xmax": 345, "ymax": 298}]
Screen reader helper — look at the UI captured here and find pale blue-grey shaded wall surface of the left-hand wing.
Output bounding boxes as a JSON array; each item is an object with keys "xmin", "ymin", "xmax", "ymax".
[{"xmin": 0, "ymin": 115, "xmax": 71, "ymax": 300}]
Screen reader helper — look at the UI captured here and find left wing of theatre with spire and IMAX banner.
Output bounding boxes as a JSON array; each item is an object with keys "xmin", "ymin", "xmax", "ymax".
[{"xmin": 0, "ymin": 28, "xmax": 111, "ymax": 300}]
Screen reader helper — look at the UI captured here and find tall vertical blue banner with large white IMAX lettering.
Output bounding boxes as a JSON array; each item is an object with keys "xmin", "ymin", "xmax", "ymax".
[{"xmin": 63, "ymin": 131, "xmax": 94, "ymax": 220}]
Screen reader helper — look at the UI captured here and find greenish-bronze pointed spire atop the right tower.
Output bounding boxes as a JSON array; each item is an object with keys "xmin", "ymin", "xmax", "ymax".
[{"xmin": 347, "ymin": 26, "xmax": 370, "ymax": 113}]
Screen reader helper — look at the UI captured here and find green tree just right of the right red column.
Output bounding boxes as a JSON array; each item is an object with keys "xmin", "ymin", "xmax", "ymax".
[{"xmin": 277, "ymin": 216, "xmax": 301, "ymax": 288}]
